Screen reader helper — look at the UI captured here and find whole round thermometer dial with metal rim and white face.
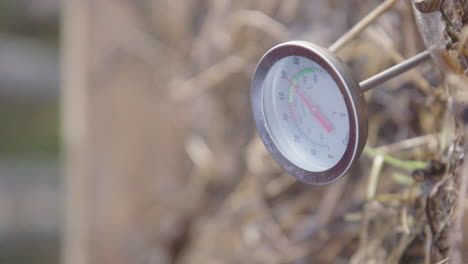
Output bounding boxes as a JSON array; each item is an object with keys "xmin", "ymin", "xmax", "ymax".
[{"xmin": 251, "ymin": 41, "xmax": 367, "ymax": 184}]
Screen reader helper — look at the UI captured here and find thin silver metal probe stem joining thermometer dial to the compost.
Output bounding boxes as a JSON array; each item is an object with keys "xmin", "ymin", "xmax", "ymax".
[{"xmin": 359, "ymin": 50, "xmax": 431, "ymax": 93}]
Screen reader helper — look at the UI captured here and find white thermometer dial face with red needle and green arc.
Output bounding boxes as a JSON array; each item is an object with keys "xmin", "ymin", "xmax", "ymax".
[{"xmin": 263, "ymin": 56, "xmax": 349, "ymax": 172}]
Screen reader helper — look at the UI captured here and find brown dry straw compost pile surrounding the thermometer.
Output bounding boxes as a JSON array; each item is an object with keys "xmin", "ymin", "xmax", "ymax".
[{"xmin": 147, "ymin": 0, "xmax": 468, "ymax": 263}]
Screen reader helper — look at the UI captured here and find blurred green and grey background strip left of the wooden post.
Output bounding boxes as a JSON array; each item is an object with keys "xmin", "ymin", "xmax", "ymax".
[{"xmin": 0, "ymin": 0, "xmax": 62, "ymax": 263}]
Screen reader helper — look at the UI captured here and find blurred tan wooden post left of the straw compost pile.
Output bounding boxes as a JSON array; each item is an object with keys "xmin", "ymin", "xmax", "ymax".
[{"xmin": 62, "ymin": 0, "xmax": 188, "ymax": 264}]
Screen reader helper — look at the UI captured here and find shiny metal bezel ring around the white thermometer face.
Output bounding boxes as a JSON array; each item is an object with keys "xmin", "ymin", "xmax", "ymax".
[{"xmin": 251, "ymin": 41, "xmax": 367, "ymax": 184}]
